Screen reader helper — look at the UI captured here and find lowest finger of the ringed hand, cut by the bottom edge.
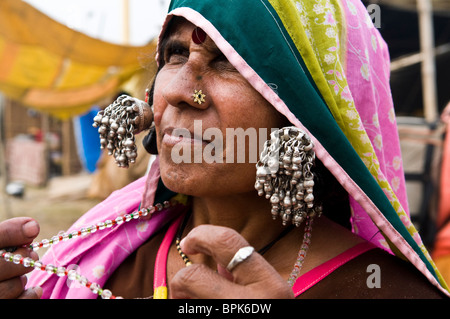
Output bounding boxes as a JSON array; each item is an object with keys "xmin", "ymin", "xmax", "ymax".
[{"xmin": 169, "ymin": 264, "xmax": 248, "ymax": 299}]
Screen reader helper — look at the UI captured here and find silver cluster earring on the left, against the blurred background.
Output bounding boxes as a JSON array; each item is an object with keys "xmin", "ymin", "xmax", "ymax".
[{"xmin": 92, "ymin": 95, "xmax": 153, "ymax": 168}]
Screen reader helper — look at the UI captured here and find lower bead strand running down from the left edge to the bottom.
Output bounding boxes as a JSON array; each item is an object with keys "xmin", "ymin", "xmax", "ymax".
[{"xmin": 0, "ymin": 250, "xmax": 122, "ymax": 299}]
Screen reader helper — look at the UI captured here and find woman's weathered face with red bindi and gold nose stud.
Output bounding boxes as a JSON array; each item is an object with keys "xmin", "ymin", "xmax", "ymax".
[{"xmin": 153, "ymin": 18, "xmax": 282, "ymax": 196}]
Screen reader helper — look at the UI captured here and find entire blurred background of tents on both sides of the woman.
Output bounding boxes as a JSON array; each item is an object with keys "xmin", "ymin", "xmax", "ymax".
[{"xmin": 0, "ymin": 0, "xmax": 450, "ymax": 281}]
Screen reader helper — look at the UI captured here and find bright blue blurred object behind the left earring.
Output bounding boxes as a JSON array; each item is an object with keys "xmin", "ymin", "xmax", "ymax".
[{"xmin": 73, "ymin": 106, "xmax": 102, "ymax": 173}]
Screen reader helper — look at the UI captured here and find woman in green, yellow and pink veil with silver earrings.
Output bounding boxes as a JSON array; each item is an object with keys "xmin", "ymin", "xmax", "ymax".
[{"xmin": 3, "ymin": 0, "xmax": 448, "ymax": 298}]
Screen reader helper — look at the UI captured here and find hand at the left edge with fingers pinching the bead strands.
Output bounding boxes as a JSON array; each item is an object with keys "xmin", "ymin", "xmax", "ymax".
[{"xmin": 0, "ymin": 217, "xmax": 42, "ymax": 299}]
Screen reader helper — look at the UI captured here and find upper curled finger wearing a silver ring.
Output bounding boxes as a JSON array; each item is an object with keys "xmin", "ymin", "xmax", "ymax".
[{"xmin": 180, "ymin": 225, "xmax": 281, "ymax": 285}]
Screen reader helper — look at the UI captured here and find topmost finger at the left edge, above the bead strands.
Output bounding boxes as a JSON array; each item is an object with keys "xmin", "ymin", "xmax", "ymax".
[{"xmin": 0, "ymin": 217, "xmax": 39, "ymax": 249}]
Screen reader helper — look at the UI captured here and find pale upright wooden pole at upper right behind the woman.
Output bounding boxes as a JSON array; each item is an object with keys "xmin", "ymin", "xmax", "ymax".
[{"xmin": 417, "ymin": 0, "xmax": 438, "ymax": 123}]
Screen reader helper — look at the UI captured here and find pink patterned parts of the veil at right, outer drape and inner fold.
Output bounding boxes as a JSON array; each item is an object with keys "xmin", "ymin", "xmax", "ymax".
[{"xmin": 342, "ymin": 1, "xmax": 409, "ymax": 251}]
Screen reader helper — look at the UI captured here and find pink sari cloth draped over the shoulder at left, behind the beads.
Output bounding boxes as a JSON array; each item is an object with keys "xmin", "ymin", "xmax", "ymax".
[{"xmin": 27, "ymin": 160, "xmax": 183, "ymax": 299}]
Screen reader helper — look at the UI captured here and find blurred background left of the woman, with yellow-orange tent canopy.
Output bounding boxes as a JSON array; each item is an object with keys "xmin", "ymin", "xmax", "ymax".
[{"xmin": 0, "ymin": 0, "xmax": 169, "ymax": 248}]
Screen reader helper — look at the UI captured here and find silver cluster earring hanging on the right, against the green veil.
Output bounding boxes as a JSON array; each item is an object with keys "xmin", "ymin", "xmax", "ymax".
[{"xmin": 255, "ymin": 126, "xmax": 322, "ymax": 227}]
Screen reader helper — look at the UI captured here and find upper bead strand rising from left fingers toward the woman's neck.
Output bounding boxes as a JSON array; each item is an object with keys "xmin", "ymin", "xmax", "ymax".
[{"xmin": 28, "ymin": 201, "xmax": 171, "ymax": 251}]
